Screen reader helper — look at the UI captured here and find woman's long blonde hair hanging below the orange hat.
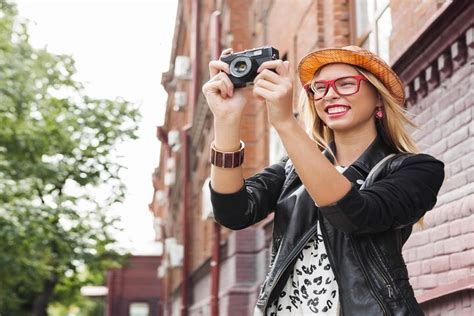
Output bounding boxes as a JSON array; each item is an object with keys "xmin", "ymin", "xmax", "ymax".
[{"xmin": 298, "ymin": 66, "xmax": 418, "ymax": 159}]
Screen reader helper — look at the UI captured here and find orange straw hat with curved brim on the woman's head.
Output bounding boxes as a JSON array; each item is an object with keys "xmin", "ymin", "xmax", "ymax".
[{"xmin": 298, "ymin": 46, "xmax": 405, "ymax": 105}]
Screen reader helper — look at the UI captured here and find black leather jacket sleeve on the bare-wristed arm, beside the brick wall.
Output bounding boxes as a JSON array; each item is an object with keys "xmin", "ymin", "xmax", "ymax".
[{"xmin": 320, "ymin": 154, "xmax": 444, "ymax": 234}]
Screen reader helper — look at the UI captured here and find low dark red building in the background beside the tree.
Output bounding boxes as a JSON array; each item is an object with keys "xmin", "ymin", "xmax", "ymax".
[{"xmin": 107, "ymin": 256, "xmax": 164, "ymax": 316}]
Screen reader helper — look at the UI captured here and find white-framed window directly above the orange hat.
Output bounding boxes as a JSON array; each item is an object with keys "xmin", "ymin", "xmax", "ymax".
[{"xmin": 353, "ymin": 0, "xmax": 392, "ymax": 63}]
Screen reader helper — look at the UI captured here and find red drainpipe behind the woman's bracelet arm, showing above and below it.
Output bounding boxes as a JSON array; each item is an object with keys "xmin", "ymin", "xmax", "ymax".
[{"xmin": 211, "ymin": 11, "xmax": 222, "ymax": 316}]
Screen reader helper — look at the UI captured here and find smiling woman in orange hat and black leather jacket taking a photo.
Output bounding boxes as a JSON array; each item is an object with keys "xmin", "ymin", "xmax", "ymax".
[{"xmin": 203, "ymin": 46, "xmax": 444, "ymax": 315}]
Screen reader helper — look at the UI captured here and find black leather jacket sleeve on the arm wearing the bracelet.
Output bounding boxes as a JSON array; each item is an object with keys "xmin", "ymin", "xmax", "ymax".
[{"xmin": 209, "ymin": 158, "xmax": 287, "ymax": 230}]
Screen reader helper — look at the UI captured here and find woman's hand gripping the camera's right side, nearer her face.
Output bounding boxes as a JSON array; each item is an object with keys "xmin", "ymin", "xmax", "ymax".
[{"xmin": 253, "ymin": 60, "xmax": 294, "ymax": 128}]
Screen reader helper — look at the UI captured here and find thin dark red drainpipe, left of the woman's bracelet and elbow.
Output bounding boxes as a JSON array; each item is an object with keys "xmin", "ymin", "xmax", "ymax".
[{"xmin": 181, "ymin": 124, "xmax": 191, "ymax": 316}]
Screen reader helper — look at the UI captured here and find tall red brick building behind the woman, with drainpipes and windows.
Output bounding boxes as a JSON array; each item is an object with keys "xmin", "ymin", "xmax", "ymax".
[{"xmin": 151, "ymin": 0, "xmax": 474, "ymax": 315}]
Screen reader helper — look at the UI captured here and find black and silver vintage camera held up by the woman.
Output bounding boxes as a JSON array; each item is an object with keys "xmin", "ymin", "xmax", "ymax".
[{"xmin": 221, "ymin": 46, "xmax": 280, "ymax": 88}]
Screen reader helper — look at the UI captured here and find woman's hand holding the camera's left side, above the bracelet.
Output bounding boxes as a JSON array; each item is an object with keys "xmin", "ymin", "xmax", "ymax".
[{"xmin": 202, "ymin": 48, "xmax": 247, "ymax": 122}]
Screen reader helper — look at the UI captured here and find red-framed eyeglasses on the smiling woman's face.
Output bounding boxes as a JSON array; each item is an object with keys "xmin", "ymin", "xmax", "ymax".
[{"xmin": 304, "ymin": 75, "xmax": 367, "ymax": 101}]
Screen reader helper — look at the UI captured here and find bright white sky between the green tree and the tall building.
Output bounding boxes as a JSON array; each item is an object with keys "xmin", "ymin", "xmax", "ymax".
[{"xmin": 16, "ymin": 0, "xmax": 178, "ymax": 254}]
